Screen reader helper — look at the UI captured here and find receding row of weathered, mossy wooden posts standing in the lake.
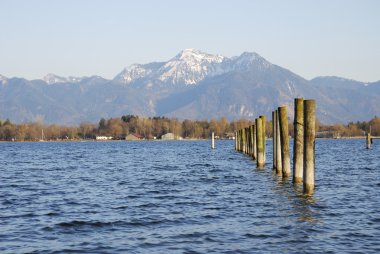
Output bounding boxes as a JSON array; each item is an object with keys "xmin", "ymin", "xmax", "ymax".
[{"xmin": 235, "ymin": 98, "xmax": 316, "ymax": 194}]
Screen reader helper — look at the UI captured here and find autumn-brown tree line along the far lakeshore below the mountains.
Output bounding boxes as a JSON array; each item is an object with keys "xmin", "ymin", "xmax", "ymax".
[{"xmin": 0, "ymin": 115, "xmax": 380, "ymax": 141}]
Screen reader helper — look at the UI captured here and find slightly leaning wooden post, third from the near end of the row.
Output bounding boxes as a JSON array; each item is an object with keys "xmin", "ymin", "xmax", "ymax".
[{"xmin": 278, "ymin": 107, "xmax": 290, "ymax": 177}]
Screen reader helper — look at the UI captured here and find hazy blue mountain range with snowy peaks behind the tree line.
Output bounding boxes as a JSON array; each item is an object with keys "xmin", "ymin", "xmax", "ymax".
[{"xmin": 0, "ymin": 49, "xmax": 380, "ymax": 124}]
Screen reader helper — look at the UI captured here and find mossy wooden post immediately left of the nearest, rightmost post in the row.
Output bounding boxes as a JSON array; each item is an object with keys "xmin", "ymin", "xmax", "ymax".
[{"xmin": 293, "ymin": 98, "xmax": 304, "ymax": 183}]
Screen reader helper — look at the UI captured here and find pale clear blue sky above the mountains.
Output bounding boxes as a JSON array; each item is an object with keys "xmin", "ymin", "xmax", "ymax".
[{"xmin": 0, "ymin": 0, "xmax": 380, "ymax": 81}]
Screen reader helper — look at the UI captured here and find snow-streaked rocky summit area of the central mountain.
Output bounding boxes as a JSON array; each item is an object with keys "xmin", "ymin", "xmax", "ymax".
[{"xmin": 114, "ymin": 49, "xmax": 271, "ymax": 85}]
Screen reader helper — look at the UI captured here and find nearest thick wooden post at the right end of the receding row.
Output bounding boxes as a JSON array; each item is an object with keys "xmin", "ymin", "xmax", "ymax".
[{"xmin": 303, "ymin": 100, "xmax": 315, "ymax": 194}]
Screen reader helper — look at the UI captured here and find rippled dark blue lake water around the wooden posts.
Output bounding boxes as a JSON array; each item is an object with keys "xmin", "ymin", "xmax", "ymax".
[{"xmin": 0, "ymin": 140, "xmax": 380, "ymax": 253}]
